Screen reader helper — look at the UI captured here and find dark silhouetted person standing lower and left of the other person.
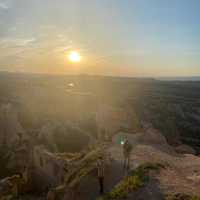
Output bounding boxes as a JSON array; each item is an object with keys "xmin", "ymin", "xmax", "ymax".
[{"xmin": 97, "ymin": 156, "xmax": 105, "ymax": 195}]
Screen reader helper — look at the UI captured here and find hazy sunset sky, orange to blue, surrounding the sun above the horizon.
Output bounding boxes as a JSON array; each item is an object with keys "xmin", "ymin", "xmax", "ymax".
[{"xmin": 0, "ymin": 0, "xmax": 200, "ymax": 77}]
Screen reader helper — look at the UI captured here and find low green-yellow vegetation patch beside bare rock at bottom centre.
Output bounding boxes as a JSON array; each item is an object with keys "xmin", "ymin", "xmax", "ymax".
[{"xmin": 97, "ymin": 163, "xmax": 164, "ymax": 200}]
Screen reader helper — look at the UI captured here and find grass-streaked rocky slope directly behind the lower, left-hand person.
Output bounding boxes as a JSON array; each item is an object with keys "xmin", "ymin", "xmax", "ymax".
[{"xmin": 45, "ymin": 146, "xmax": 123, "ymax": 200}]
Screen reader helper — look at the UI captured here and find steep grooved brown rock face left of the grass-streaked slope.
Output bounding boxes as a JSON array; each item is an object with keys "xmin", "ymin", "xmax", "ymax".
[{"xmin": 27, "ymin": 146, "xmax": 67, "ymax": 192}]
